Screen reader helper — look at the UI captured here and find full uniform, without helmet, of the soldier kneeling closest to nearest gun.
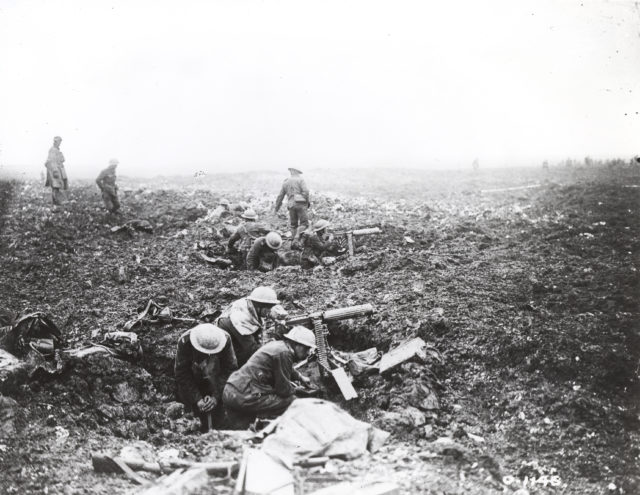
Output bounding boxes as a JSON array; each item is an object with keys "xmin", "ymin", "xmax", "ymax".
[{"xmin": 222, "ymin": 340, "xmax": 299, "ymax": 416}]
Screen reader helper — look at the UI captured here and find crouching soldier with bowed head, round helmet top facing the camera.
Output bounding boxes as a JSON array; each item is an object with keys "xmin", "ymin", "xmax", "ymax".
[{"xmin": 174, "ymin": 323, "xmax": 238, "ymax": 433}]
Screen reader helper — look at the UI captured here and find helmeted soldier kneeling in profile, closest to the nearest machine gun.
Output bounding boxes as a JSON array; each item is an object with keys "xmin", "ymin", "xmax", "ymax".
[{"xmin": 222, "ymin": 326, "xmax": 315, "ymax": 418}]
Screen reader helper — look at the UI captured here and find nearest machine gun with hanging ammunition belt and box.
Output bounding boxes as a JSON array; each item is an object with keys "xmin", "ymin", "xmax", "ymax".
[{"xmin": 283, "ymin": 304, "xmax": 376, "ymax": 400}]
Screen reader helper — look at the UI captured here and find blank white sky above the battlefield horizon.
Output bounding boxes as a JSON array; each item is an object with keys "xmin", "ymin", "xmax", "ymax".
[{"xmin": 0, "ymin": 0, "xmax": 640, "ymax": 177}]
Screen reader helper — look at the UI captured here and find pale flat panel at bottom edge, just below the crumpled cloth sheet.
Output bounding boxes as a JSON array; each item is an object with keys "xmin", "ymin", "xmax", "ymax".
[{"xmin": 235, "ymin": 449, "xmax": 295, "ymax": 495}]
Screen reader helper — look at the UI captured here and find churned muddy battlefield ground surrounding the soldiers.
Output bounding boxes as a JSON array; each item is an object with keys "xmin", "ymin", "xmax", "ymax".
[{"xmin": 0, "ymin": 167, "xmax": 640, "ymax": 493}]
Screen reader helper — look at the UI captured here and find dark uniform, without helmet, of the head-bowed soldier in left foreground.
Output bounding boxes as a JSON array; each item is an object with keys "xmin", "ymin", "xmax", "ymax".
[{"xmin": 174, "ymin": 330, "xmax": 238, "ymax": 429}]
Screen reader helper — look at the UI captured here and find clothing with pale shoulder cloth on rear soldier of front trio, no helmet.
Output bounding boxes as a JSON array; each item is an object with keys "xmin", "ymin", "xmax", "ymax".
[{"xmin": 216, "ymin": 297, "xmax": 264, "ymax": 366}]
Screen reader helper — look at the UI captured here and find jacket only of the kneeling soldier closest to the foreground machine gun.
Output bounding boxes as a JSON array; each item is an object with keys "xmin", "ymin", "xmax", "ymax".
[{"xmin": 227, "ymin": 340, "xmax": 299, "ymax": 397}]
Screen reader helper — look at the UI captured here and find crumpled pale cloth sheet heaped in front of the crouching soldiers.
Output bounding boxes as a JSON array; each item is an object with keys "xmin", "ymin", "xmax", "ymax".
[{"xmin": 262, "ymin": 399, "xmax": 384, "ymax": 465}]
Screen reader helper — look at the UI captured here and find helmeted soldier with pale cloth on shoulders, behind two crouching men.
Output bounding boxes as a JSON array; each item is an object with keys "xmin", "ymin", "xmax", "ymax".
[{"xmin": 216, "ymin": 287, "xmax": 279, "ymax": 366}]
